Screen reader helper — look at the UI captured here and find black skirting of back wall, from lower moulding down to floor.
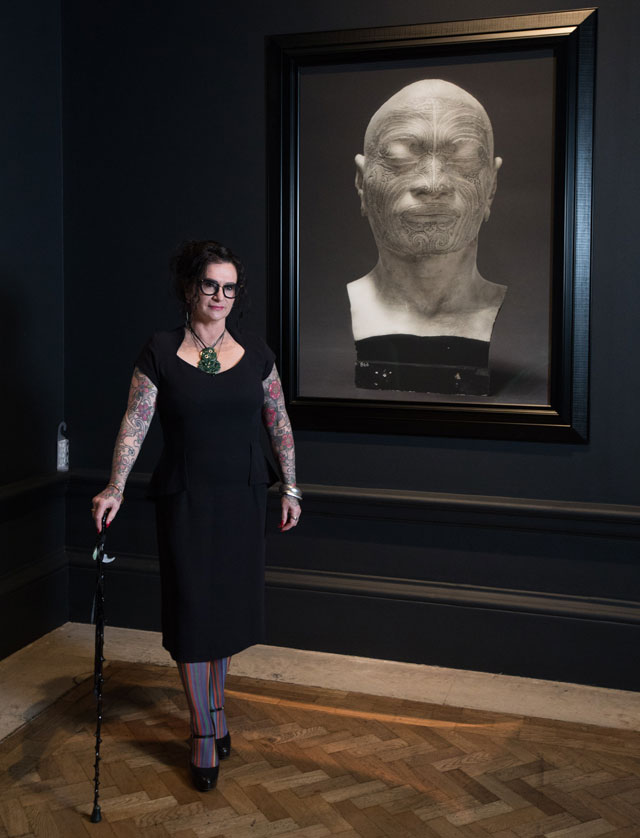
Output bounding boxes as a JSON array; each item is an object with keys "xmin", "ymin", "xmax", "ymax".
[{"xmin": 69, "ymin": 551, "xmax": 640, "ymax": 690}]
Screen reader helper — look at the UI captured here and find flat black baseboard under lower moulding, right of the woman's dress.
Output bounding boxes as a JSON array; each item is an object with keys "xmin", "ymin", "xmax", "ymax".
[{"xmin": 267, "ymin": 588, "xmax": 640, "ymax": 691}]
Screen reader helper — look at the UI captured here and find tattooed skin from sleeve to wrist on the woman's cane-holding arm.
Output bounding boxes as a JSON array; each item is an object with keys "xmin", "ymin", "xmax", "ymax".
[{"xmin": 111, "ymin": 367, "xmax": 158, "ymax": 494}]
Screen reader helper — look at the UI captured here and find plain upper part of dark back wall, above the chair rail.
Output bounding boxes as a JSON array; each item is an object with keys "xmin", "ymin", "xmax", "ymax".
[{"xmin": 64, "ymin": 0, "xmax": 640, "ymax": 503}]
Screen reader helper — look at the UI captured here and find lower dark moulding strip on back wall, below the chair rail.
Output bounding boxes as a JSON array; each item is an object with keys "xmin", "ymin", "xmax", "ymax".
[{"xmin": 67, "ymin": 549, "xmax": 640, "ymax": 624}]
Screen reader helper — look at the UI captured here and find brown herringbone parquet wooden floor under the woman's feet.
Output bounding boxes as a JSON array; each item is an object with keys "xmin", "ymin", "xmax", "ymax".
[{"xmin": 0, "ymin": 663, "xmax": 640, "ymax": 838}]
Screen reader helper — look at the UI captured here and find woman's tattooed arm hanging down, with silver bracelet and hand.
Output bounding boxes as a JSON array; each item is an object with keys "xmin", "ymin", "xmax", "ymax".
[{"xmin": 262, "ymin": 366, "xmax": 300, "ymax": 532}]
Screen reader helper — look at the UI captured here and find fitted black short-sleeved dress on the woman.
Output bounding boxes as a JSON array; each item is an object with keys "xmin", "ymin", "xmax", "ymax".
[{"xmin": 136, "ymin": 327, "xmax": 274, "ymax": 663}]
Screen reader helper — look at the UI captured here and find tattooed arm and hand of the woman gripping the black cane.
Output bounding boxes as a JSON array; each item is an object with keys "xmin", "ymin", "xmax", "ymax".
[{"xmin": 92, "ymin": 367, "xmax": 158, "ymax": 532}]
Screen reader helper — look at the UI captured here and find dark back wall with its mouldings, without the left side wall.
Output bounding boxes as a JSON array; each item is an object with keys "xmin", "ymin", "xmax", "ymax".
[{"xmin": 63, "ymin": 0, "xmax": 640, "ymax": 686}]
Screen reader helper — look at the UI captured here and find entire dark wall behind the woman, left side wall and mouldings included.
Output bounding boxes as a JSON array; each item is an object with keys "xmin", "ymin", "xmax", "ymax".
[{"xmin": 0, "ymin": 0, "xmax": 640, "ymax": 689}]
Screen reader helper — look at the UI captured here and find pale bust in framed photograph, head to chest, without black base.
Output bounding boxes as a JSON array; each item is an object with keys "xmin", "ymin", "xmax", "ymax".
[{"xmin": 348, "ymin": 79, "xmax": 506, "ymax": 394}]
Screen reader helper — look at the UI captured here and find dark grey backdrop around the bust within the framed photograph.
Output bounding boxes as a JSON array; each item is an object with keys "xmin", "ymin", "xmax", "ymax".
[{"xmin": 297, "ymin": 50, "xmax": 562, "ymax": 404}]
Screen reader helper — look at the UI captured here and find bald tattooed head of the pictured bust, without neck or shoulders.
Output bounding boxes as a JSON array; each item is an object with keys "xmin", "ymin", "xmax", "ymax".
[{"xmin": 356, "ymin": 79, "xmax": 502, "ymax": 259}]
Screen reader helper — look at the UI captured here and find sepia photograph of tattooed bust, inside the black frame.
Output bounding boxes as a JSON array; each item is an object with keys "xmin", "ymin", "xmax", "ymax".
[{"xmin": 298, "ymin": 50, "xmax": 556, "ymax": 405}]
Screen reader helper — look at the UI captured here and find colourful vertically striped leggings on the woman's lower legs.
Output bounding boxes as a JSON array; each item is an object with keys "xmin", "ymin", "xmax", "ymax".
[{"xmin": 178, "ymin": 658, "xmax": 231, "ymax": 768}]
